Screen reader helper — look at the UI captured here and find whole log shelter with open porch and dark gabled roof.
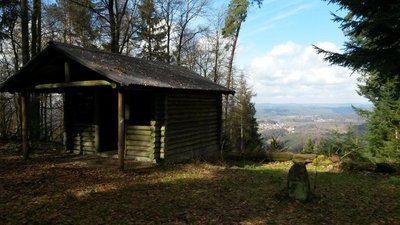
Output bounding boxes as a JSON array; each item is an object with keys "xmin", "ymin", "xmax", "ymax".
[{"xmin": 0, "ymin": 42, "xmax": 233, "ymax": 167}]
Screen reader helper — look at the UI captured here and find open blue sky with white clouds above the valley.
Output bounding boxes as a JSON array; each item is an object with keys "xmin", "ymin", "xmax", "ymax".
[{"xmin": 214, "ymin": 0, "xmax": 367, "ymax": 104}]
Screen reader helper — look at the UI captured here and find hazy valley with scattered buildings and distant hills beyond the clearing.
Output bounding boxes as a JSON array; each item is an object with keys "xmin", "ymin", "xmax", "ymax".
[{"xmin": 256, "ymin": 104, "xmax": 371, "ymax": 152}]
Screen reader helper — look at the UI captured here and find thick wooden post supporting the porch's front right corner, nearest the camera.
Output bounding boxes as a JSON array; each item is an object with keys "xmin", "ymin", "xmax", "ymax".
[{"xmin": 118, "ymin": 90, "xmax": 125, "ymax": 170}]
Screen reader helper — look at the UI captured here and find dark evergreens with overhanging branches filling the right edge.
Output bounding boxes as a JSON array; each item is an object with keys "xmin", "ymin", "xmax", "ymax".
[{"xmin": 317, "ymin": 0, "xmax": 400, "ymax": 162}]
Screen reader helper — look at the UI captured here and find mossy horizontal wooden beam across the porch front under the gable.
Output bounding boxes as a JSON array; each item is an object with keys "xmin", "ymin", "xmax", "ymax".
[{"xmin": 34, "ymin": 80, "xmax": 117, "ymax": 89}]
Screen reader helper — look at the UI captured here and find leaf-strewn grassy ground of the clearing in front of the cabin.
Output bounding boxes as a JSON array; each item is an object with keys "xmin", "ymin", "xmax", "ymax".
[{"xmin": 0, "ymin": 149, "xmax": 400, "ymax": 224}]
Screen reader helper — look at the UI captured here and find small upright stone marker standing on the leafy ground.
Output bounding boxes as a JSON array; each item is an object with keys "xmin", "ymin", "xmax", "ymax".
[{"xmin": 287, "ymin": 162, "xmax": 311, "ymax": 202}]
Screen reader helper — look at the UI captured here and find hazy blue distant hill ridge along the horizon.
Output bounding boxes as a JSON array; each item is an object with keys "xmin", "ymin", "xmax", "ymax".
[{"xmin": 255, "ymin": 103, "xmax": 372, "ymax": 117}]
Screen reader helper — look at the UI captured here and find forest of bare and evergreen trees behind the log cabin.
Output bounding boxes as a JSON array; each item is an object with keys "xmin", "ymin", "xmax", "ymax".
[{"xmin": 0, "ymin": 0, "xmax": 262, "ymax": 153}]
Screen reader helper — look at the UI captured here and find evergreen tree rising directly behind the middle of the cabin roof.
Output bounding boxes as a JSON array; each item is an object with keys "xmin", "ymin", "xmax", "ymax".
[{"xmin": 138, "ymin": 0, "xmax": 169, "ymax": 61}]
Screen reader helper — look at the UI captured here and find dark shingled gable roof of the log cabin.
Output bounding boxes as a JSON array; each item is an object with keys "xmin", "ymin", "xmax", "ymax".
[{"xmin": 0, "ymin": 42, "xmax": 233, "ymax": 94}]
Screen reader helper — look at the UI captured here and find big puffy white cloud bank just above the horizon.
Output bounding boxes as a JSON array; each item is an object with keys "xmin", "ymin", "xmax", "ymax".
[{"xmin": 249, "ymin": 42, "xmax": 366, "ymax": 103}]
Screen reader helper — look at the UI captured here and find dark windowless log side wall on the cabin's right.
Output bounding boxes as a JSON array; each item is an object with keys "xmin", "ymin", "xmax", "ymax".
[{"xmin": 164, "ymin": 93, "xmax": 221, "ymax": 162}]
